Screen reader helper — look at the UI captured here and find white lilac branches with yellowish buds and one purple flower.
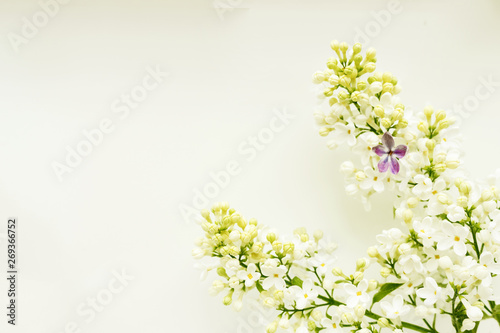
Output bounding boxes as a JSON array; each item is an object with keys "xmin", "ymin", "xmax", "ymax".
[{"xmin": 193, "ymin": 41, "xmax": 500, "ymax": 333}]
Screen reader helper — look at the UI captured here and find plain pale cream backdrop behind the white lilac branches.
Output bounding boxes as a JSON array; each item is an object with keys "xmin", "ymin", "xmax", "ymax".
[{"xmin": 0, "ymin": 0, "xmax": 500, "ymax": 333}]
